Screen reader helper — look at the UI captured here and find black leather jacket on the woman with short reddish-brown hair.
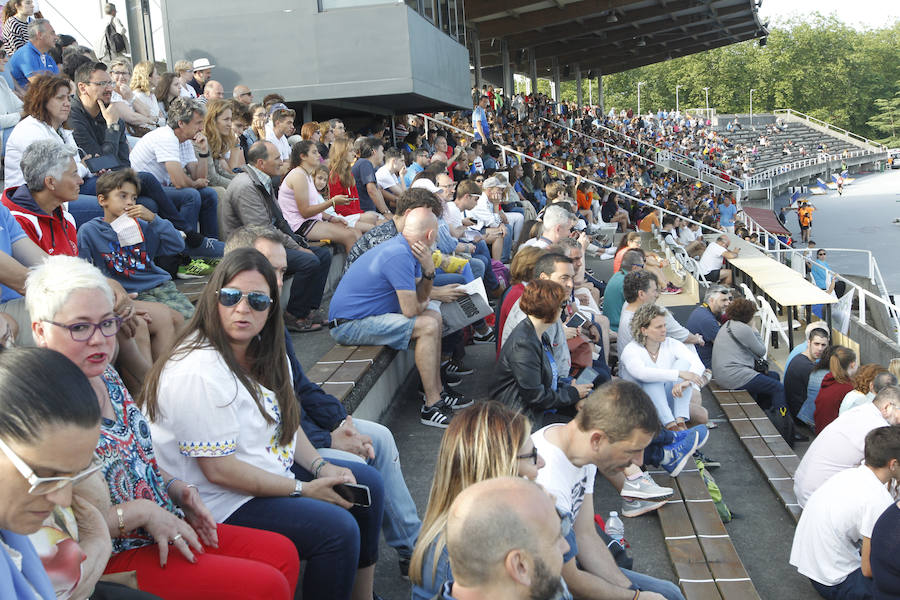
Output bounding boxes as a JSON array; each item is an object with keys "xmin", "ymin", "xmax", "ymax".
[{"xmin": 491, "ymin": 318, "xmax": 579, "ymax": 427}]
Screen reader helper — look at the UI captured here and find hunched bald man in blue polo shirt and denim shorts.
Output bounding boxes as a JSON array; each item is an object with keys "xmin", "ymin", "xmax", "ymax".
[{"xmin": 328, "ymin": 207, "xmax": 472, "ymax": 428}]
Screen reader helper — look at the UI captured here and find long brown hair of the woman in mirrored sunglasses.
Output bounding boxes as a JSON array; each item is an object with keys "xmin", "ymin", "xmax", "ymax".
[{"xmin": 138, "ymin": 248, "xmax": 300, "ymax": 446}]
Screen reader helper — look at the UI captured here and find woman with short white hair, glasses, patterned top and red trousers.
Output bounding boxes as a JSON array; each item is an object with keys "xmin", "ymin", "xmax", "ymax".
[{"xmin": 26, "ymin": 256, "xmax": 299, "ymax": 600}]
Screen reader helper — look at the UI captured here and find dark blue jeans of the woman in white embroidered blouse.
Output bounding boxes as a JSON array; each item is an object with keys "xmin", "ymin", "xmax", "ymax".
[{"xmin": 225, "ymin": 461, "xmax": 384, "ymax": 600}]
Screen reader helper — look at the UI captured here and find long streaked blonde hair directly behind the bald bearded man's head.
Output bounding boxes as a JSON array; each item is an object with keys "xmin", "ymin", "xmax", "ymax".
[{"xmin": 409, "ymin": 400, "xmax": 531, "ymax": 584}]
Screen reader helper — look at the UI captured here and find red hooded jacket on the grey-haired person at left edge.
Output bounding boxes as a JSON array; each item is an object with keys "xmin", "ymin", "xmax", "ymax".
[{"xmin": 2, "ymin": 186, "xmax": 78, "ymax": 256}]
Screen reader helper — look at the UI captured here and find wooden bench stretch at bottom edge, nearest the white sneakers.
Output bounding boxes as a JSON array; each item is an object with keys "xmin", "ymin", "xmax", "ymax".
[{"xmin": 653, "ymin": 469, "xmax": 760, "ymax": 600}]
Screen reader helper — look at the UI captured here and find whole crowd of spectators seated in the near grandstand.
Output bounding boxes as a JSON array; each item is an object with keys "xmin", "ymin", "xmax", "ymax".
[{"xmin": 0, "ymin": 15, "xmax": 900, "ymax": 600}]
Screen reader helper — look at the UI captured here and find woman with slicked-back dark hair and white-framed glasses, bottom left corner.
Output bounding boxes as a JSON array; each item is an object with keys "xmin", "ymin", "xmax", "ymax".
[{"xmin": 0, "ymin": 348, "xmax": 102, "ymax": 600}]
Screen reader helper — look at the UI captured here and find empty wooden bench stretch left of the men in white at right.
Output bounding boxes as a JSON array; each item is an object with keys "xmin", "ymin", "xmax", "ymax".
[{"xmin": 709, "ymin": 382, "xmax": 802, "ymax": 521}]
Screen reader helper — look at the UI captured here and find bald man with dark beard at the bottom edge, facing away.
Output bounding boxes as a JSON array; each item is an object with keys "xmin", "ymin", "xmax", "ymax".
[{"xmin": 438, "ymin": 477, "xmax": 571, "ymax": 600}]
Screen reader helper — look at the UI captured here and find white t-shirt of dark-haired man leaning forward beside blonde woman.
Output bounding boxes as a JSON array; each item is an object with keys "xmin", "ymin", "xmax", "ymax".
[{"xmin": 531, "ymin": 424, "xmax": 597, "ymax": 518}]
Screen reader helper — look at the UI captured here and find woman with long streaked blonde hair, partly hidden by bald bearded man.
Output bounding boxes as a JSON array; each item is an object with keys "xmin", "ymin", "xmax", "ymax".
[{"xmin": 409, "ymin": 401, "xmax": 574, "ymax": 600}]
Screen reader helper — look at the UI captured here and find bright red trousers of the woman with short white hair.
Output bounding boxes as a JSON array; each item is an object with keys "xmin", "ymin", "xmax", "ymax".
[{"xmin": 106, "ymin": 523, "xmax": 300, "ymax": 600}]
